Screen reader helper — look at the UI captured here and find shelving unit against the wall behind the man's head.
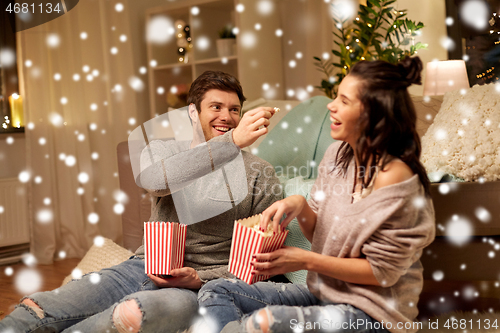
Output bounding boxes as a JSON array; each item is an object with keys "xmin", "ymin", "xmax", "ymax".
[{"xmin": 146, "ymin": 0, "xmax": 239, "ymax": 117}]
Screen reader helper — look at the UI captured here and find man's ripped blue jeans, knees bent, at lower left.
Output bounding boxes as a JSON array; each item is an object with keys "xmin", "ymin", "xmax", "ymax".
[{"xmin": 0, "ymin": 257, "xmax": 198, "ymax": 333}]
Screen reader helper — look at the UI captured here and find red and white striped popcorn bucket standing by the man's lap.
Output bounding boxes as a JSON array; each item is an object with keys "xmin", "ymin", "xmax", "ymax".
[{"xmin": 144, "ymin": 222, "xmax": 187, "ymax": 275}]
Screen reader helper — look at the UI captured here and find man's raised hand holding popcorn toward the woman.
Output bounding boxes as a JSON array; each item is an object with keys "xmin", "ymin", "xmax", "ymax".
[{"xmin": 233, "ymin": 107, "xmax": 276, "ymax": 148}]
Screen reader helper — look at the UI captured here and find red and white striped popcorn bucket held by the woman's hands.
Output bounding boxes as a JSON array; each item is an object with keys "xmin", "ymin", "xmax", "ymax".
[{"xmin": 228, "ymin": 214, "xmax": 288, "ymax": 284}]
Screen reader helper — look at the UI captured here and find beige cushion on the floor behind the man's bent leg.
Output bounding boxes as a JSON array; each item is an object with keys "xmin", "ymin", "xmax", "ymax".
[{"xmin": 62, "ymin": 238, "xmax": 134, "ymax": 285}]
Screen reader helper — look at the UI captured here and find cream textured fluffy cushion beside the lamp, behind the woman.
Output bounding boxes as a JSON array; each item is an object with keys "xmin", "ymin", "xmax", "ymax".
[{"xmin": 421, "ymin": 83, "xmax": 500, "ymax": 182}]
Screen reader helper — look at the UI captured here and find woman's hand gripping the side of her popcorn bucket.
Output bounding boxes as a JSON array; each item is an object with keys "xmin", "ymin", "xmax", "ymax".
[{"xmin": 251, "ymin": 246, "xmax": 311, "ymax": 275}]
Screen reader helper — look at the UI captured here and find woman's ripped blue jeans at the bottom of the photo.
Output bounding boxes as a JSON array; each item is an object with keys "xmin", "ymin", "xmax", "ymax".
[{"xmin": 198, "ymin": 279, "xmax": 389, "ymax": 333}]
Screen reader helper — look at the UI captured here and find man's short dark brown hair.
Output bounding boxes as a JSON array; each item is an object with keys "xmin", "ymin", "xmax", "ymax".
[{"xmin": 187, "ymin": 71, "xmax": 246, "ymax": 113}]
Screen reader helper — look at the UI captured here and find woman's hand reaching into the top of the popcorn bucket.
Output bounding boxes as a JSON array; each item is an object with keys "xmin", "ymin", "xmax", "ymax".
[{"xmin": 260, "ymin": 195, "xmax": 306, "ymax": 232}]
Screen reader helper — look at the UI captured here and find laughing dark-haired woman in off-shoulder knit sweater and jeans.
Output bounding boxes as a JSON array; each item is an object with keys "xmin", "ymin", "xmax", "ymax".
[{"xmin": 198, "ymin": 58, "xmax": 435, "ymax": 332}]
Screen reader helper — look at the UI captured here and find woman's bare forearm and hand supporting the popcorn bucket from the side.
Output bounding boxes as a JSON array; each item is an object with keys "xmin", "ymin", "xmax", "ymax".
[{"xmin": 252, "ymin": 246, "xmax": 380, "ymax": 286}]
